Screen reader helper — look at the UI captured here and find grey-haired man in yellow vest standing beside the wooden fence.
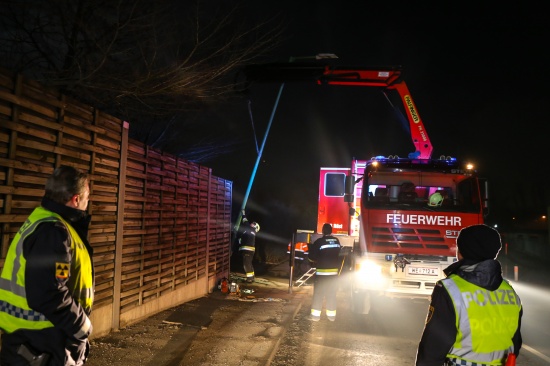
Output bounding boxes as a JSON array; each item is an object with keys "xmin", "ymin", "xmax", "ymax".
[{"xmin": 0, "ymin": 166, "xmax": 93, "ymax": 366}]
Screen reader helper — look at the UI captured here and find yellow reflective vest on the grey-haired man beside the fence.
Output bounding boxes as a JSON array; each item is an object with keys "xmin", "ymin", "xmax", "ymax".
[{"xmin": 0, "ymin": 206, "xmax": 94, "ymax": 333}]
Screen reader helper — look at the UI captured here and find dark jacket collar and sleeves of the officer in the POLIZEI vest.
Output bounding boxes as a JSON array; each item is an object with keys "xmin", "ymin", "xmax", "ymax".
[{"xmin": 416, "ymin": 260, "xmax": 523, "ymax": 366}]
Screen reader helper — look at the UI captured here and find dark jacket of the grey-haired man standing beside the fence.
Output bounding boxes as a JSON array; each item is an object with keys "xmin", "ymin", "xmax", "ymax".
[{"xmin": 0, "ymin": 198, "xmax": 93, "ymax": 365}]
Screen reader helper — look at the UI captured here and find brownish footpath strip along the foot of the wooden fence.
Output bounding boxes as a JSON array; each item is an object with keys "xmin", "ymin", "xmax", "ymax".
[{"xmin": 87, "ymin": 274, "xmax": 311, "ymax": 366}]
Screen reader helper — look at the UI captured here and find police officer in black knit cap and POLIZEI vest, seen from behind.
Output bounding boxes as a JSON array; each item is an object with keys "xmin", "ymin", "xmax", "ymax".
[{"xmin": 416, "ymin": 225, "xmax": 523, "ymax": 366}]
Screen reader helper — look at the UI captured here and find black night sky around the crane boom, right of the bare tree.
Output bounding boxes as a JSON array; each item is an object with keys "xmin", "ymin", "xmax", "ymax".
[{"xmin": 209, "ymin": 0, "xmax": 550, "ymax": 242}]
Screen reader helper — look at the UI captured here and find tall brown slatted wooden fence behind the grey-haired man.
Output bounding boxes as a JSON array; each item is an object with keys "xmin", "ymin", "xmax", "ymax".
[{"xmin": 0, "ymin": 71, "xmax": 232, "ymax": 337}]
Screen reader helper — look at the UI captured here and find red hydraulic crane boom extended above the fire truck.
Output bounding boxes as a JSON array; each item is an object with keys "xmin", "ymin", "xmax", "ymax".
[{"xmin": 245, "ymin": 63, "xmax": 433, "ymax": 159}]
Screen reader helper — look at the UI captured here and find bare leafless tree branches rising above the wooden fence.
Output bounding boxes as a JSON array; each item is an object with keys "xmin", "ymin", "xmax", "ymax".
[{"xmin": 0, "ymin": 0, "xmax": 282, "ymax": 162}]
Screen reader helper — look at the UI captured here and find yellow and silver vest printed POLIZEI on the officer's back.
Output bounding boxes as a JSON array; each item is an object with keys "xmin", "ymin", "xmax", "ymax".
[{"xmin": 441, "ymin": 275, "xmax": 521, "ymax": 365}]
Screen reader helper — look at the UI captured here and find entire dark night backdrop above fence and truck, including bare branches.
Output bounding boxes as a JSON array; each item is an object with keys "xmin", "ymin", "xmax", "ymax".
[{"xmin": 0, "ymin": 0, "xmax": 550, "ymax": 243}]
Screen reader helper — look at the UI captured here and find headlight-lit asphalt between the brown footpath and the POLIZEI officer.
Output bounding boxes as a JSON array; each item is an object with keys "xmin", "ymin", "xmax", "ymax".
[{"xmin": 273, "ymin": 291, "xmax": 428, "ymax": 366}]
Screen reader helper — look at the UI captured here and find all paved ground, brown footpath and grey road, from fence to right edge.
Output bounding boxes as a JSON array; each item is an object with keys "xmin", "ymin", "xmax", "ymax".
[{"xmin": 88, "ymin": 254, "xmax": 550, "ymax": 366}]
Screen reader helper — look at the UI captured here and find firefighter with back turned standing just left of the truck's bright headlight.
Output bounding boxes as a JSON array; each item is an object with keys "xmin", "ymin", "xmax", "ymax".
[{"xmin": 308, "ymin": 224, "xmax": 342, "ymax": 321}]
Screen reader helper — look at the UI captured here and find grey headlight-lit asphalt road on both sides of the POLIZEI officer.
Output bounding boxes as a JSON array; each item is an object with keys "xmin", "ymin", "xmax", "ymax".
[{"xmin": 272, "ymin": 284, "xmax": 550, "ymax": 366}]
